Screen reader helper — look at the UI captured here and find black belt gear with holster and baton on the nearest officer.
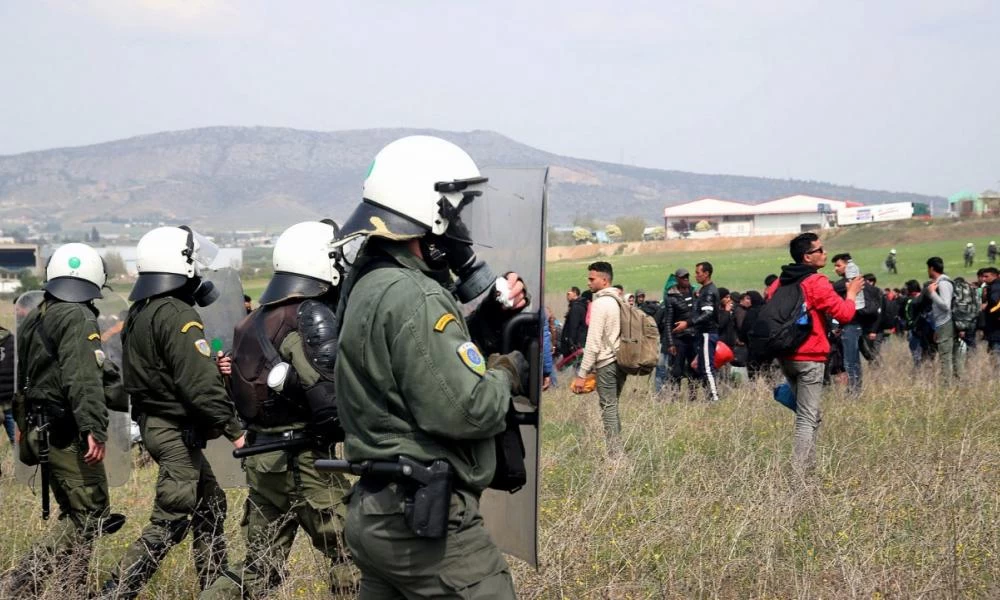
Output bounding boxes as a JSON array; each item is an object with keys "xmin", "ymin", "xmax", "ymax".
[{"xmin": 316, "ymin": 456, "xmax": 455, "ymax": 539}]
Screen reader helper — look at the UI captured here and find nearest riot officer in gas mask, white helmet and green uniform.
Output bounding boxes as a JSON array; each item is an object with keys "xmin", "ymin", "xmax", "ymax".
[{"xmin": 334, "ymin": 136, "xmax": 528, "ymax": 599}]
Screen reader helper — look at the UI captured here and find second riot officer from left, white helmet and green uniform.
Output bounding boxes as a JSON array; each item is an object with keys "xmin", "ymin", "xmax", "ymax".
[{"xmin": 104, "ymin": 227, "xmax": 243, "ymax": 598}]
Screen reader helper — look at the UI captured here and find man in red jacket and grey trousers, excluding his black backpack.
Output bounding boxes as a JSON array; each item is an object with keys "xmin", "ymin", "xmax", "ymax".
[{"xmin": 767, "ymin": 233, "xmax": 864, "ymax": 473}]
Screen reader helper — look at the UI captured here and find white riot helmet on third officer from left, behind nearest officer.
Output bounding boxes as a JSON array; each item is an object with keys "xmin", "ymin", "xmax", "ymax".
[{"xmin": 260, "ymin": 221, "xmax": 342, "ymax": 305}]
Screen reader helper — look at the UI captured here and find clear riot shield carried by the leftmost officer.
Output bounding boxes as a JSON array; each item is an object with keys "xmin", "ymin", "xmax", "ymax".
[{"xmin": 14, "ymin": 291, "xmax": 132, "ymax": 488}]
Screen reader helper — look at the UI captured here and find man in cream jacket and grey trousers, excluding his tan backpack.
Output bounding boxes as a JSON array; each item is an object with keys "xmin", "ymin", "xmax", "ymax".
[{"xmin": 572, "ymin": 261, "xmax": 625, "ymax": 456}]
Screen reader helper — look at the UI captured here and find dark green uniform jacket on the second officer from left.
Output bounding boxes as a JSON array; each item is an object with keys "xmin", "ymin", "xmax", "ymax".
[{"xmin": 123, "ymin": 296, "xmax": 241, "ymax": 440}]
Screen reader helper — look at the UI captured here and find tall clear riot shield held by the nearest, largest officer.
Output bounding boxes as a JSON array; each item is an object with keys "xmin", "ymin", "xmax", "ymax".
[{"xmin": 462, "ymin": 168, "xmax": 548, "ymax": 567}]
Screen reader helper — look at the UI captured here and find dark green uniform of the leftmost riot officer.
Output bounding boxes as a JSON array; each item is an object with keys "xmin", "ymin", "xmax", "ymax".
[{"xmin": 5, "ymin": 297, "xmax": 114, "ymax": 591}]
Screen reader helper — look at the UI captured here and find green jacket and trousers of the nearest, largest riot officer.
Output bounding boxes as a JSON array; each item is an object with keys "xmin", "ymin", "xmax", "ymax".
[{"xmin": 335, "ymin": 241, "xmax": 516, "ymax": 598}]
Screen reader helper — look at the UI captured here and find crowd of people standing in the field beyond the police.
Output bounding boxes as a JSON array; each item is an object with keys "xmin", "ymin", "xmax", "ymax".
[{"xmin": 547, "ymin": 233, "xmax": 1000, "ymax": 469}]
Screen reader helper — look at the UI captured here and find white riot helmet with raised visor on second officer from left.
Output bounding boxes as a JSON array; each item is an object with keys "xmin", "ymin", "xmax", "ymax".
[{"xmin": 129, "ymin": 225, "xmax": 219, "ymax": 306}]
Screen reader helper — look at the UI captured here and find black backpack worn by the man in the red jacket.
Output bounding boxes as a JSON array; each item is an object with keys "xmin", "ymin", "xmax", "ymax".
[{"xmin": 747, "ymin": 282, "xmax": 812, "ymax": 360}]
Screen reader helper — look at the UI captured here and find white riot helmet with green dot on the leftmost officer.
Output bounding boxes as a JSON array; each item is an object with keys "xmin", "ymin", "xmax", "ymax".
[{"xmin": 44, "ymin": 243, "xmax": 108, "ymax": 302}]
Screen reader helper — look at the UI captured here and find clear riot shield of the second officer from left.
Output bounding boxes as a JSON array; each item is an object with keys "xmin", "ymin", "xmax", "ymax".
[{"xmin": 195, "ymin": 268, "xmax": 247, "ymax": 489}]
